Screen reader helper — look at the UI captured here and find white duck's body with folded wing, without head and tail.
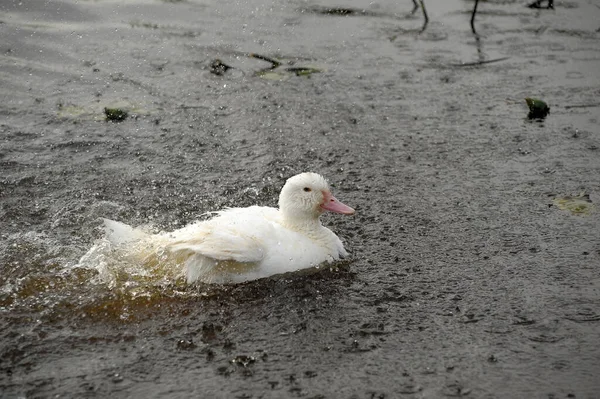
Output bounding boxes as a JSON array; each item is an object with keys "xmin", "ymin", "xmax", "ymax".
[{"xmin": 166, "ymin": 206, "xmax": 348, "ymax": 283}]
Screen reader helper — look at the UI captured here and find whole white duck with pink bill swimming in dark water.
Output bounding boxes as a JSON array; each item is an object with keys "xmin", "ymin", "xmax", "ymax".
[{"xmin": 99, "ymin": 173, "xmax": 354, "ymax": 283}]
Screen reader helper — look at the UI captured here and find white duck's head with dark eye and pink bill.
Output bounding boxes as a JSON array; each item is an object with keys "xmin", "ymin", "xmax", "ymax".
[{"xmin": 279, "ymin": 172, "xmax": 354, "ymax": 222}]
